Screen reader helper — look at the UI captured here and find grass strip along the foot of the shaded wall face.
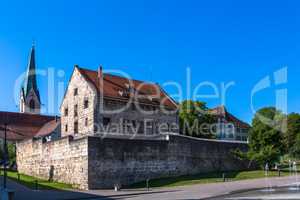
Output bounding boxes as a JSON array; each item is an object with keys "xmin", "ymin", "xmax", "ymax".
[{"xmin": 129, "ymin": 170, "xmax": 296, "ymax": 188}]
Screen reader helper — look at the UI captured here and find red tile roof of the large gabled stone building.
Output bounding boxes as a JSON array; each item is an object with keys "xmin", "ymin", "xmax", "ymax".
[{"xmin": 78, "ymin": 67, "xmax": 178, "ymax": 109}]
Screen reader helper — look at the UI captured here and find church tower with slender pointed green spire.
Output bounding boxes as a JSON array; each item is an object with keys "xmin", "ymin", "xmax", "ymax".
[{"xmin": 20, "ymin": 45, "xmax": 41, "ymax": 114}]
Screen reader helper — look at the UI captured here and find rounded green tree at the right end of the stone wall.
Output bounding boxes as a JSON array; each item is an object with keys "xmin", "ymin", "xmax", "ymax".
[{"xmin": 247, "ymin": 107, "xmax": 286, "ymax": 166}]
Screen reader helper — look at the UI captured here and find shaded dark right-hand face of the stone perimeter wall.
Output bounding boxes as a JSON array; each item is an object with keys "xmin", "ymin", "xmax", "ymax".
[{"xmin": 88, "ymin": 136, "xmax": 248, "ymax": 189}]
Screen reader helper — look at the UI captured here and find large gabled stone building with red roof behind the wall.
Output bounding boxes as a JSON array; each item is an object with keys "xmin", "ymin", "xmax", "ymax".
[{"xmin": 61, "ymin": 66, "xmax": 178, "ymax": 137}]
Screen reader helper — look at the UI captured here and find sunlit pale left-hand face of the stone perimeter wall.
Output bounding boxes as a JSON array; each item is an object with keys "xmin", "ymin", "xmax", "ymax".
[{"xmin": 17, "ymin": 137, "xmax": 88, "ymax": 189}]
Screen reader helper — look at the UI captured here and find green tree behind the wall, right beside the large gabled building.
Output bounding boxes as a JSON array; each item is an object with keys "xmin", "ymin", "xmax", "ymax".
[{"xmin": 179, "ymin": 100, "xmax": 215, "ymax": 138}]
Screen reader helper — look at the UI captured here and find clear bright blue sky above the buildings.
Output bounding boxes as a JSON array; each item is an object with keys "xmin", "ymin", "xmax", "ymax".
[{"xmin": 0, "ymin": 0, "xmax": 300, "ymax": 122}]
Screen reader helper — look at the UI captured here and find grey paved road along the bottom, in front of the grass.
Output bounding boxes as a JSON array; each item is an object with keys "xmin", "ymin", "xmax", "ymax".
[{"xmin": 1, "ymin": 177, "xmax": 296, "ymax": 200}]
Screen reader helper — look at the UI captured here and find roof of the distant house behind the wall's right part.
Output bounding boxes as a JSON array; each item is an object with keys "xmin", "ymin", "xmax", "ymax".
[{"xmin": 209, "ymin": 106, "xmax": 251, "ymax": 129}]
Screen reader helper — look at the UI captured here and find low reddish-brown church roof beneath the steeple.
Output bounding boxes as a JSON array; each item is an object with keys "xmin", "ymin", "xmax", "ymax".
[{"xmin": 0, "ymin": 111, "xmax": 60, "ymax": 140}]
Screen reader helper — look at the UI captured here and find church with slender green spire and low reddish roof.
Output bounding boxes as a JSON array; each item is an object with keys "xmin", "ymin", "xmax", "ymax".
[{"xmin": 0, "ymin": 46, "xmax": 61, "ymax": 141}]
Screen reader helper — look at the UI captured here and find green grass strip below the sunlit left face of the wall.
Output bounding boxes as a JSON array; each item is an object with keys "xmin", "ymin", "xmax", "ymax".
[{"xmin": 1, "ymin": 171, "xmax": 72, "ymax": 190}]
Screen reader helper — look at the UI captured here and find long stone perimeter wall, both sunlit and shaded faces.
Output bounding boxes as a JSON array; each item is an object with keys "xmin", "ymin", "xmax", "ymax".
[{"xmin": 17, "ymin": 135, "xmax": 248, "ymax": 189}]
